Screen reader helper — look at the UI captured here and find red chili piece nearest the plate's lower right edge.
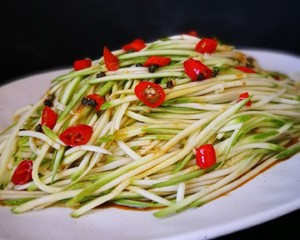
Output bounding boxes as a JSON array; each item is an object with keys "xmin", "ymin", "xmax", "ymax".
[{"xmin": 196, "ymin": 144, "xmax": 217, "ymax": 169}]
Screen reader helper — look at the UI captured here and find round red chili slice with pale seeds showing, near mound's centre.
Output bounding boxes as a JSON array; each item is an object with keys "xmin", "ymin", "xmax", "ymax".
[{"xmin": 134, "ymin": 82, "xmax": 166, "ymax": 108}]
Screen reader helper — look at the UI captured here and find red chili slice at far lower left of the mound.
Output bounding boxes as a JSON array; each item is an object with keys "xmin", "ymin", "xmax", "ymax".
[{"xmin": 11, "ymin": 160, "xmax": 33, "ymax": 185}]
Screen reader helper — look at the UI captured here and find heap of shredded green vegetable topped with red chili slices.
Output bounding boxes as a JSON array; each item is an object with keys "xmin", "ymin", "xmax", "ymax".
[{"xmin": 0, "ymin": 32, "xmax": 300, "ymax": 217}]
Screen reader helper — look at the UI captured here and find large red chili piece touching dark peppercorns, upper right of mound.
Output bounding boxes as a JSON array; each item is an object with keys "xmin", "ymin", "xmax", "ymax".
[{"xmin": 183, "ymin": 58, "xmax": 213, "ymax": 81}]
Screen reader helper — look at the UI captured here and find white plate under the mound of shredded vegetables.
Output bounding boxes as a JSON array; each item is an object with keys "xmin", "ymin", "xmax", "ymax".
[{"xmin": 0, "ymin": 50, "xmax": 300, "ymax": 240}]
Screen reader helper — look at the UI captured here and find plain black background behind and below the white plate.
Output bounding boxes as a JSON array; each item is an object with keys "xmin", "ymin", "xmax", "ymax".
[{"xmin": 0, "ymin": 0, "xmax": 300, "ymax": 240}]
